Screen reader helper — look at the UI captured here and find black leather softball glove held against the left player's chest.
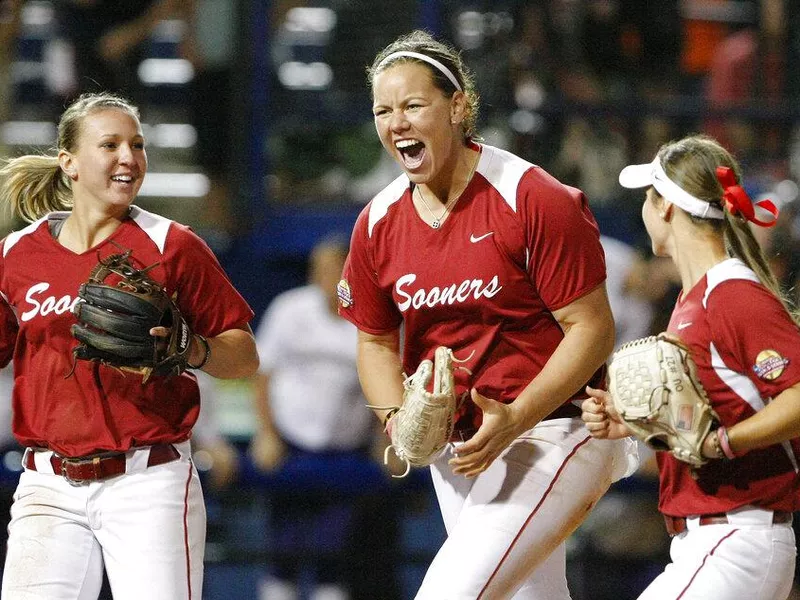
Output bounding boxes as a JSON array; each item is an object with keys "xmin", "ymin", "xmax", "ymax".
[{"xmin": 72, "ymin": 250, "xmax": 192, "ymax": 383}]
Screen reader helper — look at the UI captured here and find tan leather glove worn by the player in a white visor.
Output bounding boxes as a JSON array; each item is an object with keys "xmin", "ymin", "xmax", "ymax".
[{"xmin": 609, "ymin": 333, "xmax": 719, "ymax": 467}]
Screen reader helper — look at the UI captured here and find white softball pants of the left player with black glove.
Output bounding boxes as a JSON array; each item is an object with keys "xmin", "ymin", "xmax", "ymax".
[{"xmin": 2, "ymin": 442, "xmax": 206, "ymax": 600}]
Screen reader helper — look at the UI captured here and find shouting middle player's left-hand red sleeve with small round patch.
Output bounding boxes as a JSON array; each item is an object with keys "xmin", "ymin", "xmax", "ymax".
[{"xmin": 338, "ymin": 205, "xmax": 402, "ymax": 335}]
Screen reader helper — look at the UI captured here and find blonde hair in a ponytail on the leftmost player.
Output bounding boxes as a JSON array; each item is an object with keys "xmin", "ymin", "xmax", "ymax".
[{"xmin": 0, "ymin": 93, "xmax": 139, "ymax": 223}]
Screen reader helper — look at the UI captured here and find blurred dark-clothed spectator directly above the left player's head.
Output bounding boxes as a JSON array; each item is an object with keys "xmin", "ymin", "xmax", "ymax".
[{"xmin": 47, "ymin": 0, "xmax": 185, "ymax": 105}]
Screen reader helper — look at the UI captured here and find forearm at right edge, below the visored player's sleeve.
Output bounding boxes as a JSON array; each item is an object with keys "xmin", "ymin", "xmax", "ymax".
[{"xmin": 727, "ymin": 383, "xmax": 800, "ymax": 454}]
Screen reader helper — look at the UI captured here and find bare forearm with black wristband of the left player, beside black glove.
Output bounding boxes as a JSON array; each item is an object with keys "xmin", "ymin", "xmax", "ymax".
[{"xmin": 189, "ymin": 327, "xmax": 258, "ymax": 379}]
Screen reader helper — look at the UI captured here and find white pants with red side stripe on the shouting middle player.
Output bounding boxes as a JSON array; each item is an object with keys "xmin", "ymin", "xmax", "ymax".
[{"xmin": 416, "ymin": 419, "xmax": 638, "ymax": 600}]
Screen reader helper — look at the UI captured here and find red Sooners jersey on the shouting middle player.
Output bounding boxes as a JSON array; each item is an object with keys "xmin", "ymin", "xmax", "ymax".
[{"xmin": 339, "ymin": 145, "xmax": 605, "ymax": 431}]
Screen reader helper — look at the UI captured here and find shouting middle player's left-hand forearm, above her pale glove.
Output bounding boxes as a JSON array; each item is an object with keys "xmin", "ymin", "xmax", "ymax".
[{"xmin": 357, "ymin": 332, "xmax": 403, "ymax": 421}]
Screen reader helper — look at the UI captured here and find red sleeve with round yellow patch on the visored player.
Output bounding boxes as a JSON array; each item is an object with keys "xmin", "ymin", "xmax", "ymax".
[{"xmin": 707, "ymin": 280, "xmax": 800, "ymax": 398}]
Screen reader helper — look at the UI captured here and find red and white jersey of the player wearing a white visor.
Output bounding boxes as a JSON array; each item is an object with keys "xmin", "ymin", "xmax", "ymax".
[{"xmin": 657, "ymin": 258, "xmax": 800, "ymax": 516}]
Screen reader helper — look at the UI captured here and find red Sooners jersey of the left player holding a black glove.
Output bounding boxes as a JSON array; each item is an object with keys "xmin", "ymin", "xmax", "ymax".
[{"xmin": 0, "ymin": 207, "xmax": 253, "ymax": 456}]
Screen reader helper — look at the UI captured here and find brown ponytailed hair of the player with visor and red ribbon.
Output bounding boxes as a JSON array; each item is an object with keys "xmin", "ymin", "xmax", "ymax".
[{"xmin": 658, "ymin": 134, "xmax": 800, "ymax": 323}]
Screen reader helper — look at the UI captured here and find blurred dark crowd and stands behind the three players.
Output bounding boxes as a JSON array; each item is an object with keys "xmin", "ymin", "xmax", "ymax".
[{"xmin": 0, "ymin": 0, "xmax": 800, "ymax": 600}]
